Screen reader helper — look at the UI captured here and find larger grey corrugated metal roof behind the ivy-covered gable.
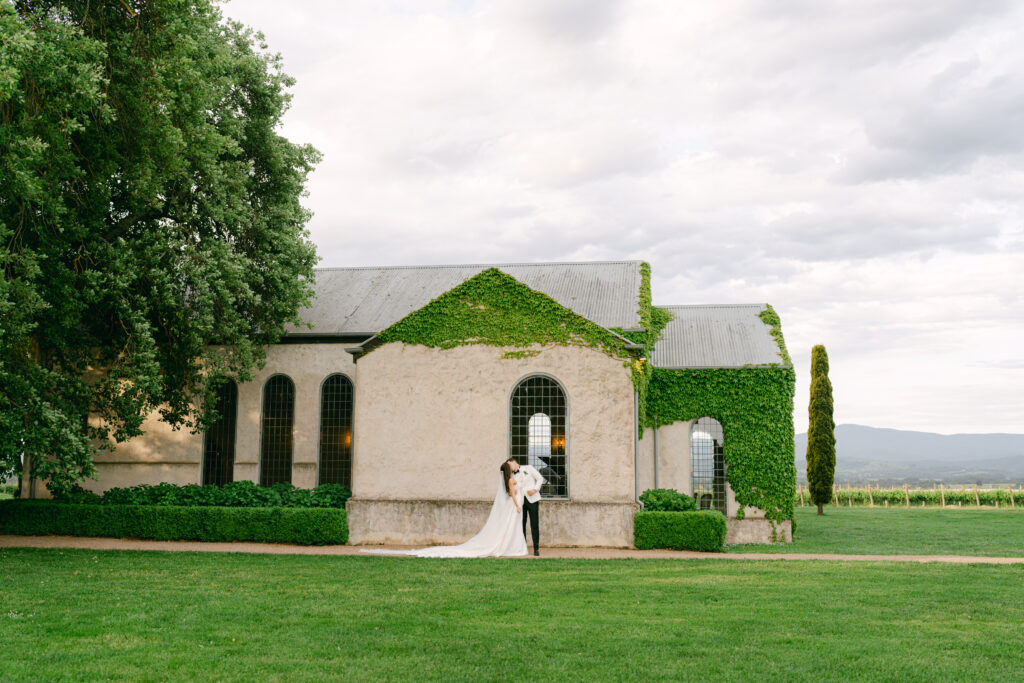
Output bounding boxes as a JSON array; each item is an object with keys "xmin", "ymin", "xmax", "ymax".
[{"xmin": 288, "ymin": 261, "xmax": 641, "ymax": 335}]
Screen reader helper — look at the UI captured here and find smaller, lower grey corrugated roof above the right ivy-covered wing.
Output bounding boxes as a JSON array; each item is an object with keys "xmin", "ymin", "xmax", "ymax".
[{"xmin": 650, "ymin": 303, "xmax": 782, "ymax": 368}]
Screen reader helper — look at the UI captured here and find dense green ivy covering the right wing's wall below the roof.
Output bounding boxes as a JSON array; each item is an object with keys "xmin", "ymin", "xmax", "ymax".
[{"xmin": 643, "ymin": 367, "xmax": 797, "ymax": 521}]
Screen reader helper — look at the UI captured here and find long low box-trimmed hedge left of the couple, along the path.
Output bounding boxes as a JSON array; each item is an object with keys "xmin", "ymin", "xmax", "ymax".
[{"xmin": 0, "ymin": 501, "xmax": 348, "ymax": 546}]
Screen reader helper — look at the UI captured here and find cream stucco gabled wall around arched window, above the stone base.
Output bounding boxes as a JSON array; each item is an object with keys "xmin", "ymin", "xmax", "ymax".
[{"xmin": 352, "ymin": 343, "xmax": 634, "ymax": 504}]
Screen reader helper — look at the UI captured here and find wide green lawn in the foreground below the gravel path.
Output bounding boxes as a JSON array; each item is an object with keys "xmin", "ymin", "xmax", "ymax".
[{"xmin": 0, "ymin": 549, "xmax": 1024, "ymax": 681}]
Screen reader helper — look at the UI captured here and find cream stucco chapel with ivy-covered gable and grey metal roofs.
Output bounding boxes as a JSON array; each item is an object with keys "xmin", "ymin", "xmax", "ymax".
[{"xmin": 64, "ymin": 261, "xmax": 796, "ymax": 547}]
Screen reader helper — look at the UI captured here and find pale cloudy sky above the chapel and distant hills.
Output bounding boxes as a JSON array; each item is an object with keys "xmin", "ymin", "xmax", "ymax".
[{"xmin": 224, "ymin": 0, "xmax": 1024, "ymax": 433}]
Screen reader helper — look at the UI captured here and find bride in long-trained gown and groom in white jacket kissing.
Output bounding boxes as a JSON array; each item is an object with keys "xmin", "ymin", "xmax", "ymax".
[{"xmin": 361, "ymin": 459, "xmax": 545, "ymax": 557}]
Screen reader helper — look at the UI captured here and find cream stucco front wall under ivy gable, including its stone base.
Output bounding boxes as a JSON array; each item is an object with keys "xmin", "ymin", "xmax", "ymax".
[{"xmin": 349, "ymin": 343, "xmax": 636, "ymax": 546}]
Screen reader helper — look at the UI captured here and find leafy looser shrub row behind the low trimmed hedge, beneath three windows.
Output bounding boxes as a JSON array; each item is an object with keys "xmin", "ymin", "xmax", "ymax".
[{"xmin": 59, "ymin": 481, "xmax": 352, "ymax": 508}]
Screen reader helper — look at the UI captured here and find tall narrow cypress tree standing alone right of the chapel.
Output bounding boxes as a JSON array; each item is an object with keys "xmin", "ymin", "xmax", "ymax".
[{"xmin": 807, "ymin": 344, "xmax": 836, "ymax": 515}]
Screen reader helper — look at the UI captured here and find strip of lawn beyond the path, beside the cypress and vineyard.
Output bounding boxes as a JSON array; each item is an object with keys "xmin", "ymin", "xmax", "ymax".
[{"xmin": 727, "ymin": 507, "xmax": 1024, "ymax": 557}]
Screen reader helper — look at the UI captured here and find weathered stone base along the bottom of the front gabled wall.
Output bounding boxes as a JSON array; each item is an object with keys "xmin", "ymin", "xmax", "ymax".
[{"xmin": 346, "ymin": 498, "xmax": 637, "ymax": 548}]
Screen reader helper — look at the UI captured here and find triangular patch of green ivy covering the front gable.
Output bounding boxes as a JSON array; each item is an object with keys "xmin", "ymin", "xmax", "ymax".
[{"xmin": 377, "ymin": 268, "xmax": 630, "ymax": 358}]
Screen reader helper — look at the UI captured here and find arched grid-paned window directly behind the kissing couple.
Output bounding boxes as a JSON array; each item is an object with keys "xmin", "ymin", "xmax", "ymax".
[{"xmin": 509, "ymin": 375, "xmax": 569, "ymax": 498}]
